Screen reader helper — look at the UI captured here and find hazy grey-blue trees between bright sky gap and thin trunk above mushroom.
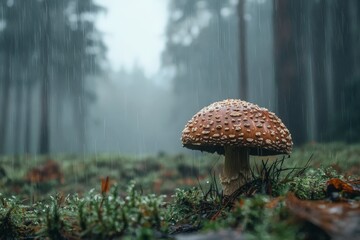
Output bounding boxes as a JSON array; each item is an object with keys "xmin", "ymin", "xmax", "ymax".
[{"xmin": 162, "ymin": 0, "xmax": 239, "ymax": 142}]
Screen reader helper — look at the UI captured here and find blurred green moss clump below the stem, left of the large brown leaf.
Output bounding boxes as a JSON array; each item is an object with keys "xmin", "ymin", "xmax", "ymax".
[{"xmin": 204, "ymin": 194, "xmax": 298, "ymax": 239}]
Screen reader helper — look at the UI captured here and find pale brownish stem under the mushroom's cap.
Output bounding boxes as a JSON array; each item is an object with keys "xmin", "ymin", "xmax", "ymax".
[{"xmin": 220, "ymin": 146, "xmax": 250, "ymax": 196}]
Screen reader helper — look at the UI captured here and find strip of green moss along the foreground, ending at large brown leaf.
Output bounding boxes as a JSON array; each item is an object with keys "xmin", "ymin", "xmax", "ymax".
[{"xmin": 0, "ymin": 185, "xmax": 304, "ymax": 239}]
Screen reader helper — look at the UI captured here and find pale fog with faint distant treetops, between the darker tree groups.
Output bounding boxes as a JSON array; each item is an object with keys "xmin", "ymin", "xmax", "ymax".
[{"xmin": 89, "ymin": 66, "xmax": 176, "ymax": 155}]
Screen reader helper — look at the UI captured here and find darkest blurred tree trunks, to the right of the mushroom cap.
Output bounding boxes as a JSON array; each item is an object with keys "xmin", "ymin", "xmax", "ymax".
[{"xmin": 274, "ymin": 0, "xmax": 360, "ymax": 142}]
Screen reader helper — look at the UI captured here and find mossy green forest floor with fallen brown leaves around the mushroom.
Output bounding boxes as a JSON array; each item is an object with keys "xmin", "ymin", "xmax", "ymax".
[{"xmin": 0, "ymin": 143, "xmax": 360, "ymax": 240}]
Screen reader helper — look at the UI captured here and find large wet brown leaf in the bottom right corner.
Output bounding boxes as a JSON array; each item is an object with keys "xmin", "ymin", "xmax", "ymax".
[{"xmin": 285, "ymin": 190, "xmax": 360, "ymax": 240}]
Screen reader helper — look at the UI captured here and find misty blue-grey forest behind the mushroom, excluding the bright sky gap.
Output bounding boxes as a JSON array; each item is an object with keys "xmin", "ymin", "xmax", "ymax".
[{"xmin": 0, "ymin": 0, "xmax": 360, "ymax": 154}]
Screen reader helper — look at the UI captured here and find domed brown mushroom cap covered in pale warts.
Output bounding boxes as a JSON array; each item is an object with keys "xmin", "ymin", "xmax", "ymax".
[{"xmin": 181, "ymin": 99, "xmax": 293, "ymax": 155}]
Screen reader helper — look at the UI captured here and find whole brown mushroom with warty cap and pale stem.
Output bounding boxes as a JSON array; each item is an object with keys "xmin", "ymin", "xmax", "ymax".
[{"xmin": 181, "ymin": 99, "xmax": 293, "ymax": 195}]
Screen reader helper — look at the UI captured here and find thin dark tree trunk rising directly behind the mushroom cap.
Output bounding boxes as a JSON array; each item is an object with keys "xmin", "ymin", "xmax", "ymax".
[{"xmin": 238, "ymin": 0, "xmax": 248, "ymax": 100}]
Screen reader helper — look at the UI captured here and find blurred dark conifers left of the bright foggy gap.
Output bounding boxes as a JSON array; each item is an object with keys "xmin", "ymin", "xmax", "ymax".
[{"xmin": 0, "ymin": 0, "xmax": 105, "ymax": 154}]
